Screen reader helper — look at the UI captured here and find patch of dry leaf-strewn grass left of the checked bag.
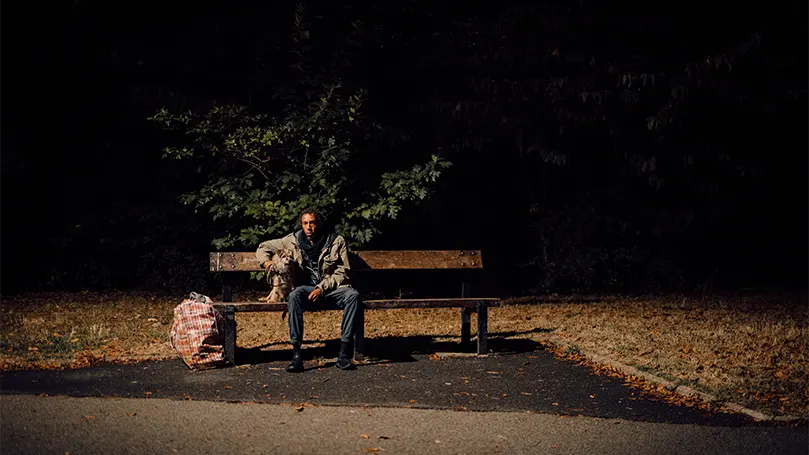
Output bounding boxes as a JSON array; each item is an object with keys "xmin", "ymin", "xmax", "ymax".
[{"xmin": 0, "ymin": 293, "xmax": 178, "ymax": 370}]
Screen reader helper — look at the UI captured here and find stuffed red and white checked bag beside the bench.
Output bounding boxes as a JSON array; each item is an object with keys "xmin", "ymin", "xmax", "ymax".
[{"xmin": 170, "ymin": 292, "xmax": 226, "ymax": 370}]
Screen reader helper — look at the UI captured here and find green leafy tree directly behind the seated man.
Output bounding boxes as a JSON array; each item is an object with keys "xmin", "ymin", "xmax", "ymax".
[{"xmin": 150, "ymin": 5, "xmax": 450, "ymax": 253}]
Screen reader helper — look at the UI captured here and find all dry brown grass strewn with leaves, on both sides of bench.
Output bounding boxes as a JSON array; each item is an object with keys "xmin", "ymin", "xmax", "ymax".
[{"xmin": 0, "ymin": 293, "xmax": 809, "ymax": 416}]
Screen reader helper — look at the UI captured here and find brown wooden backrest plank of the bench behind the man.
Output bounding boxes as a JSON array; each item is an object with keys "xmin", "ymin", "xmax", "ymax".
[{"xmin": 210, "ymin": 250, "xmax": 483, "ymax": 272}]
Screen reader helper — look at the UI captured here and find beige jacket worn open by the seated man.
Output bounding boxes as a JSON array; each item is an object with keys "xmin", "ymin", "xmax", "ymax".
[{"xmin": 256, "ymin": 232, "xmax": 351, "ymax": 294}]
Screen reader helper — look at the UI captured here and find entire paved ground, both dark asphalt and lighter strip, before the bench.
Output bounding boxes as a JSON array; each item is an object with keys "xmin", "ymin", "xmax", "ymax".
[{"xmin": 0, "ymin": 350, "xmax": 809, "ymax": 454}]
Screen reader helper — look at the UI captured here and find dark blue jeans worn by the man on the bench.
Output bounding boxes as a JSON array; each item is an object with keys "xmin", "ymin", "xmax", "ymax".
[{"xmin": 289, "ymin": 286, "xmax": 362, "ymax": 344}]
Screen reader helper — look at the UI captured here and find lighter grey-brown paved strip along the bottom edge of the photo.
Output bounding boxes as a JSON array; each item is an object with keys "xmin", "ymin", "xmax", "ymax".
[{"xmin": 0, "ymin": 395, "xmax": 807, "ymax": 455}]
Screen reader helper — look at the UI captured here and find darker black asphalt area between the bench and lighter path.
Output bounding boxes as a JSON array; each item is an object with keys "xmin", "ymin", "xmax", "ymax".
[{"xmin": 0, "ymin": 349, "xmax": 784, "ymax": 426}]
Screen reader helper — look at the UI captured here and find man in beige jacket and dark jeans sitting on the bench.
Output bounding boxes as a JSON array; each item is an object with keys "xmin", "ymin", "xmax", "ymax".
[{"xmin": 256, "ymin": 208, "xmax": 362, "ymax": 373}]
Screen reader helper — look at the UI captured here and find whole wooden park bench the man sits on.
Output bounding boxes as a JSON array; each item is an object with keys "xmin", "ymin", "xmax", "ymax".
[{"xmin": 210, "ymin": 250, "xmax": 500, "ymax": 364}]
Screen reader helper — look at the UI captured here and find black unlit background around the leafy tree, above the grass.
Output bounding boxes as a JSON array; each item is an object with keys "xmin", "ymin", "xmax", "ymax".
[{"xmin": 0, "ymin": 0, "xmax": 809, "ymax": 295}]
